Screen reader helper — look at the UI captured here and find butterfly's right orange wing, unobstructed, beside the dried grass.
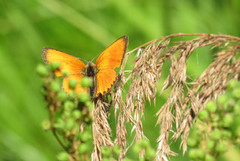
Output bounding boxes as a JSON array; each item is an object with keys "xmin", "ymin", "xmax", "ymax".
[{"xmin": 96, "ymin": 36, "xmax": 128, "ymax": 96}]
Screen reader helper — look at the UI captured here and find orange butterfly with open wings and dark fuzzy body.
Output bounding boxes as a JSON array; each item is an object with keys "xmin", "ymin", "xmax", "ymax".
[{"xmin": 43, "ymin": 36, "xmax": 128, "ymax": 98}]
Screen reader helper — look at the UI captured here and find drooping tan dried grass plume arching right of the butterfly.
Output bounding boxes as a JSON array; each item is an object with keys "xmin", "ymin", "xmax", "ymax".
[{"xmin": 93, "ymin": 34, "xmax": 240, "ymax": 161}]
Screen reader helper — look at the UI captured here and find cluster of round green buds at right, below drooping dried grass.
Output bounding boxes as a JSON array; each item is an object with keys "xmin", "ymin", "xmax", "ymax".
[{"xmin": 187, "ymin": 80, "xmax": 240, "ymax": 161}]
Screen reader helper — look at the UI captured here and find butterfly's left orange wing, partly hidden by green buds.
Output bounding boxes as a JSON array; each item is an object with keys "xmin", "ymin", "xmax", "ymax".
[{"xmin": 43, "ymin": 48, "xmax": 85, "ymax": 93}]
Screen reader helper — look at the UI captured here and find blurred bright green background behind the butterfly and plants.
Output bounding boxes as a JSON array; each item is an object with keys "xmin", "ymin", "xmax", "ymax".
[{"xmin": 0, "ymin": 0, "xmax": 240, "ymax": 161}]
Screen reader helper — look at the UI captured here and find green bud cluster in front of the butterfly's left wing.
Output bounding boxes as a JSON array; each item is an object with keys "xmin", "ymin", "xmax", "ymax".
[{"xmin": 37, "ymin": 62, "xmax": 92, "ymax": 161}]
